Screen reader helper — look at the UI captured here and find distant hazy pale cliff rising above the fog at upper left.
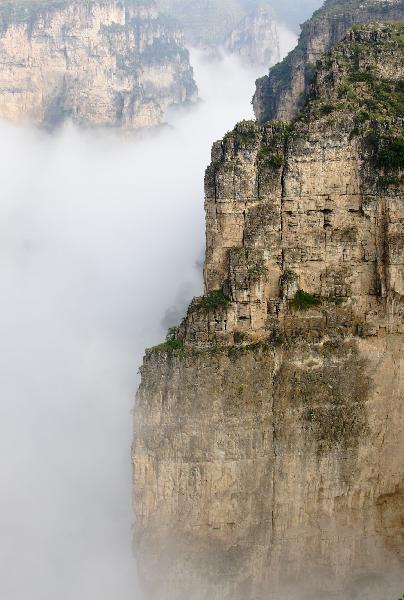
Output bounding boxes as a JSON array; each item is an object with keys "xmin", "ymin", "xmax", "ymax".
[{"xmin": 0, "ymin": 0, "xmax": 196, "ymax": 129}]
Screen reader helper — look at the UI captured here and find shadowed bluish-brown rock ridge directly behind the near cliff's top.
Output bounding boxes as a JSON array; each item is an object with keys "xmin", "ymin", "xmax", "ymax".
[{"xmin": 253, "ymin": 0, "xmax": 404, "ymax": 123}]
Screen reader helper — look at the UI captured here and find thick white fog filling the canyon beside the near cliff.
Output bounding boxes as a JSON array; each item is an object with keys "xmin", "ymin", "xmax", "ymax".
[{"xmin": 0, "ymin": 34, "xmax": 294, "ymax": 600}]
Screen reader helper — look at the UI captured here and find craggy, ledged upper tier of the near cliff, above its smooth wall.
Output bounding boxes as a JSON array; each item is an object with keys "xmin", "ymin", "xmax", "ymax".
[{"xmin": 152, "ymin": 22, "xmax": 404, "ymax": 350}]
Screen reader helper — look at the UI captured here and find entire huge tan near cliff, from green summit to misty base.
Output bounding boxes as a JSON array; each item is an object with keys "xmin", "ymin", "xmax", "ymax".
[{"xmin": 133, "ymin": 19, "xmax": 404, "ymax": 600}]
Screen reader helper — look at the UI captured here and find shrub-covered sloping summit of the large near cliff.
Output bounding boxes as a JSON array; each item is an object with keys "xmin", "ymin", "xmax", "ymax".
[{"xmin": 298, "ymin": 21, "xmax": 404, "ymax": 133}]
